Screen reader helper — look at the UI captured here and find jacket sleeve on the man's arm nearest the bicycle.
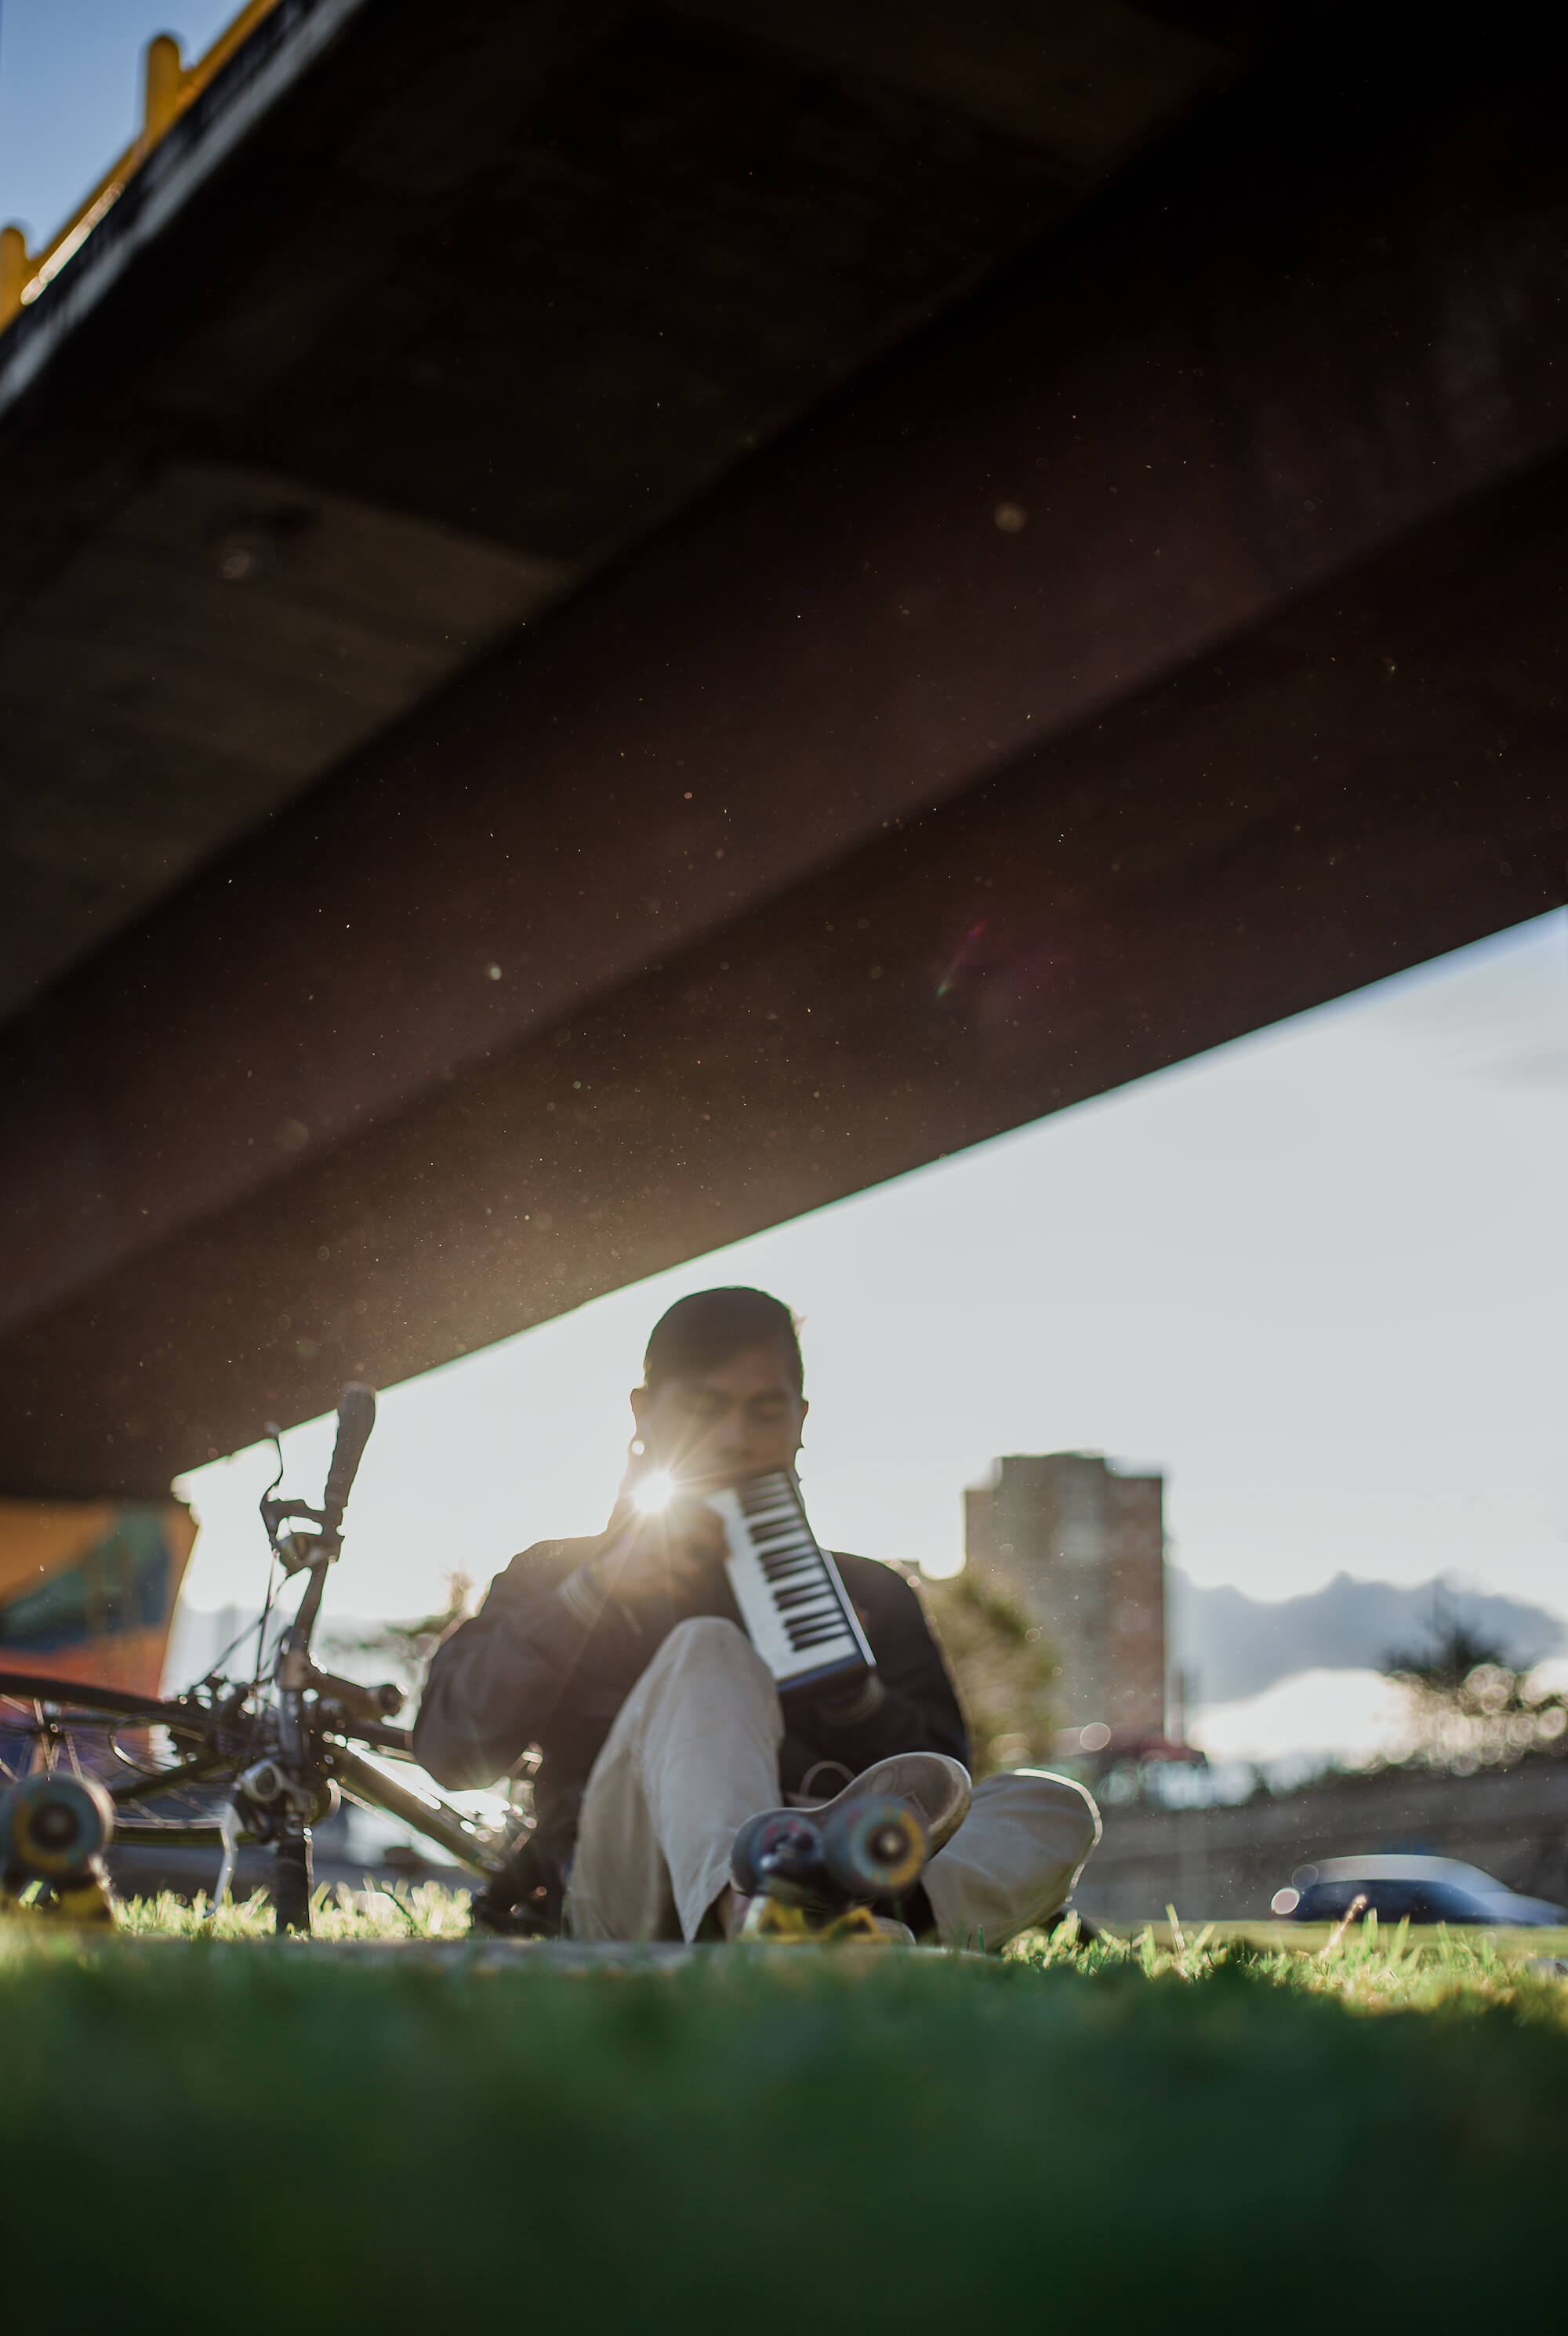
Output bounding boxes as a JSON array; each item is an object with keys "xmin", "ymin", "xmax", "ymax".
[{"xmin": 414, "ymin": 1542, "xmax": 645, "ymax": 1792}]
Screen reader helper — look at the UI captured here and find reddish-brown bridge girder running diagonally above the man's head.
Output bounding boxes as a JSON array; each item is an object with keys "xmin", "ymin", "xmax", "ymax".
[{"xmin": 0, "ymin": 12, "xmax": 1568, "ymax": 1493}]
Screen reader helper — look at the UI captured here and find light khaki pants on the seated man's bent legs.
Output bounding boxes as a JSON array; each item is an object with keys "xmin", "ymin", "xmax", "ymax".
[{"xmin": 565, "ymin": 1616, "xmax": 1101, "ymax": 1948}]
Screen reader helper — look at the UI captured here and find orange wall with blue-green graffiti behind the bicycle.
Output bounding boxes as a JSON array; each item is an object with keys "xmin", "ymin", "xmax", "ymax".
[{"xmin": 0, "ymin": 1500, "xmax": 196, "ymax": 1696}]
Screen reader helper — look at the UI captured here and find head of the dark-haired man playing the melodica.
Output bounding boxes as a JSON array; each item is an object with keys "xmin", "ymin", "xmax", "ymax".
[{"xmin": 631, "ymin": 1289, "xmax": 806, "ymax": 1486}]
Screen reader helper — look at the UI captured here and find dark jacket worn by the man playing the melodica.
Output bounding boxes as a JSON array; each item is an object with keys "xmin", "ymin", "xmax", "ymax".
[{"xmin": 414, "ymin": 1542, "xmax": 970, "ymax": 1878}]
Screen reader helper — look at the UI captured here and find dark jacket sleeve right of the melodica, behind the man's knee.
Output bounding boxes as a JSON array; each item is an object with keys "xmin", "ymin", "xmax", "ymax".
[{"xmin": 811, "ymin": 1558, "xmax": 970, "ymax": 1768}]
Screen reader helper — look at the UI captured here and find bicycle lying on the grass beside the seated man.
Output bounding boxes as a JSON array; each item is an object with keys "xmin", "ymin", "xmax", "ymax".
[{"xmin": 0, "ymin": 1386, "xmax": 533, "ymax": 1932}]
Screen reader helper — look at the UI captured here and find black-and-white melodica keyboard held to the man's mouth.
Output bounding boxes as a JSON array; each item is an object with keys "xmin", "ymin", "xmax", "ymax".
[{"xmin": 708, "ymin": 1470, "xmax": 877, "ymax": 1689}]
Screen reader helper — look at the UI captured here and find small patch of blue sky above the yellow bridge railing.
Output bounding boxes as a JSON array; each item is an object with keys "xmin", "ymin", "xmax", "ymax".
[{"xmin": 0, "ymin": 0, "xmax": 238, "ymax": 248}]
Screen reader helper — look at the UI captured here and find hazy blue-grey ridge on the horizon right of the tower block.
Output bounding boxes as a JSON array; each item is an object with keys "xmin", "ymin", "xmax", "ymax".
[{"xmin": 1166, "ymin": 1568, "xmax": 1568, "ymax": 1706}]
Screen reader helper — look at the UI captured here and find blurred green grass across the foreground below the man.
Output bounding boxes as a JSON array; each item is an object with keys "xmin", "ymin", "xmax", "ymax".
[{"xmin": 0, "ymin": 1892, "xmax": 1568, "ymax": 2336}]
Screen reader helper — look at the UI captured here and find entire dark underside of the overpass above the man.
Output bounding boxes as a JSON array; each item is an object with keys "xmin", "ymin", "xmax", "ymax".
[{"xmin": 0, "ymin": 0, "xmax": 1568, "ymax": 1495}]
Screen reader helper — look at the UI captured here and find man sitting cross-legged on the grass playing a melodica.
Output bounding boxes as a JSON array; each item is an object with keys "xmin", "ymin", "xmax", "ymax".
[{"xmin": 414, "ymin": 1289, "xmax": 1101, "ymax": 1948}]
